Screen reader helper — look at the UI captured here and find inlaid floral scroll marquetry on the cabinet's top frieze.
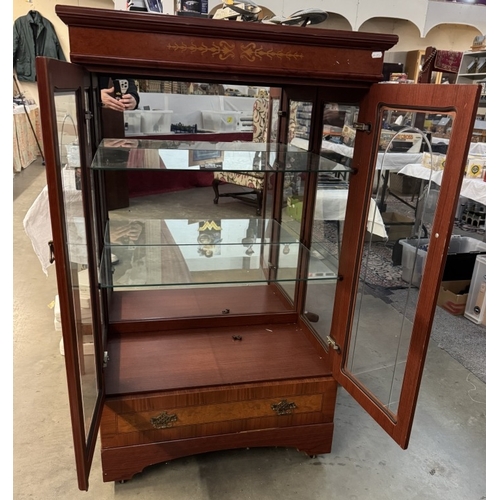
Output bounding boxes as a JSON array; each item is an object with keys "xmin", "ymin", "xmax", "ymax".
[{"xmin": 166, "ymin": 40, "xmax": 304, "ymax": 62}]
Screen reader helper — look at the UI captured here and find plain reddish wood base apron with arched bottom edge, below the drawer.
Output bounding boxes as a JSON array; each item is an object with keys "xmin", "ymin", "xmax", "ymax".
[{"xmin": 101, "ymin": 423, "xmax": 333, "ymax": 481}]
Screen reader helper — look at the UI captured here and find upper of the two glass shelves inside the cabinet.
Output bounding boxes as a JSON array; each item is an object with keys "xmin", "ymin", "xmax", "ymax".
[{"xmin": 91, "ymin": 139, "xmax": 352, "ymax": 173}]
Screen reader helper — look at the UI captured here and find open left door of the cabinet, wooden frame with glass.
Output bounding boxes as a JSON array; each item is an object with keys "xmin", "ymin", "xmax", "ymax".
[{"xmin": 37, "ymin": 58, "xmax": 103, "ymax": 490}]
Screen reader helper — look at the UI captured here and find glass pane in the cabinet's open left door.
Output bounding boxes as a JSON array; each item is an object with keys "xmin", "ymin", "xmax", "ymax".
[{"xmin": 55, "ymin": 93, "xmax": 98, "ymax": 435}]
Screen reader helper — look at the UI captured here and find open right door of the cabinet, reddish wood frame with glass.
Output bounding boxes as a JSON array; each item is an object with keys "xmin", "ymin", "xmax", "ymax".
[{"xmin": 330, "ymin": 84, "xmax": 480, "ymax": 449}]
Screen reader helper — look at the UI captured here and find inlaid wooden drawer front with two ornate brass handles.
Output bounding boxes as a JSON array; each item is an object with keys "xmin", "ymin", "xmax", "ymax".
[{"xmin": 101, "ymin": 377, "xmax": 336, "ymax": 448}]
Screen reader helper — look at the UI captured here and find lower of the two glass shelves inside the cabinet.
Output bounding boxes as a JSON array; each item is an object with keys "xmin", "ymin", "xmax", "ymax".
[{"xmin": 100, "ymin": 219, "xmax": 337, "ymax": 289}]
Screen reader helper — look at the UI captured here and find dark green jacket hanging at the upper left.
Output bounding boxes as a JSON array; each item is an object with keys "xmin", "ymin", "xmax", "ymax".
[{"xmin": 14, "ymin": 10, "xmax": 66, "ymax": 82}]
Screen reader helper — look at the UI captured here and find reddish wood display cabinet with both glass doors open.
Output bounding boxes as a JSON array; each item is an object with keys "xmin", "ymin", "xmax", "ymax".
[{"xmin": 37, "ymin": 6, "xmax": 480, "ymax": 490}]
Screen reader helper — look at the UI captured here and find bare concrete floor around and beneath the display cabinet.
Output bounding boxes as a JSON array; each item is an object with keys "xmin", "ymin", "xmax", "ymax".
[{"xmin": 13, "ymin": 162, "xmax": 486, "ymax": 500}]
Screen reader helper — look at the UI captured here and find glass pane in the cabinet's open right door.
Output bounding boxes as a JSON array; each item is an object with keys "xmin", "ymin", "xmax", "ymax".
[{"xmin": 346, "ymin": 109, "xmax": 453, "ymax": 419}]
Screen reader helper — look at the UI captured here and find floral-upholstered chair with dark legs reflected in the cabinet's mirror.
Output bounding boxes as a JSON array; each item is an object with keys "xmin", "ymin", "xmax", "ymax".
[{"xmin": 212, "ymin": 97, "xmax": 269, "ymax": 215}]
